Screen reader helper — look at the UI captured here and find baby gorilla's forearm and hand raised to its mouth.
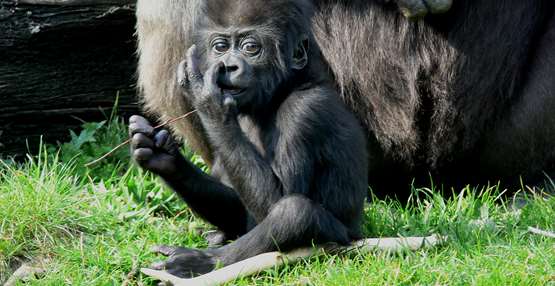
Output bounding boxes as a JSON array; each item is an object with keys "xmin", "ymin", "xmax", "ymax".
[{"xmin": 181, "ymin": 53, "xmax": 300, "ymax": 222}]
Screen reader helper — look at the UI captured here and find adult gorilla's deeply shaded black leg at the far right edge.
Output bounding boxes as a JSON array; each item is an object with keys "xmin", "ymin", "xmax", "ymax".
[{"xmin": 478, "ymin": 17, "xmax": 555, "ymax": 183}]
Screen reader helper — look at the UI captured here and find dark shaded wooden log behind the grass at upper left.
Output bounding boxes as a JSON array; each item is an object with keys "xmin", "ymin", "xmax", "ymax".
[{"xmin": 0, "ymin": 0, "xmax": 138, "ymax": 157}]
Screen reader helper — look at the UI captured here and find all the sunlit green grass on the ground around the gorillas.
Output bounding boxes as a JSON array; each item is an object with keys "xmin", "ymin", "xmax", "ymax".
[{"xmin": 0, "ymin": 117, "xmax": 555, "ymax": 286}]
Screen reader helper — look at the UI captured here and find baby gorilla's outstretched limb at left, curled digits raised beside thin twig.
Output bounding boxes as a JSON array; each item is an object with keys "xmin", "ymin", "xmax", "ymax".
[{"xmin": 129, "ymin": 116, "xmax": 247, "ymax": 238}]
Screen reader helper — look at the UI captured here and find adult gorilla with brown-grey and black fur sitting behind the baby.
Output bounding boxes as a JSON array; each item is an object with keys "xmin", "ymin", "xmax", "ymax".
[{"xmin": 137, "ymin": 0, "xmax": 555, "ymax": 197}]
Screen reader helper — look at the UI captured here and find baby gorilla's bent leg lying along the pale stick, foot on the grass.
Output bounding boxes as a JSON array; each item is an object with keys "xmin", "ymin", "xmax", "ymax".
[{"xmin": 153, "ymin": 195, "xmax": 350, "ymax": 277}]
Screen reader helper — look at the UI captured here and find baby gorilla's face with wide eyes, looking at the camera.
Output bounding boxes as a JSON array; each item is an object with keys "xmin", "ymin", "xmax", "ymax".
[{"xmin": 201, "ymin": 27, "xmax": 308, "ymax": 110}]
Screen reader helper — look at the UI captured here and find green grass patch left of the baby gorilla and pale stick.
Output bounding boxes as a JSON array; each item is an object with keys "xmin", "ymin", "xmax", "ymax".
[{"xmin": 0, "ymin": 144, "xmax": 205, "ymax": 285}]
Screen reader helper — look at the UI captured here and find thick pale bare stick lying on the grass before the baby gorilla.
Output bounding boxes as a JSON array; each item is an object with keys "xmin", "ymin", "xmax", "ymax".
[{"xmin": 141, "ymin": 235, "xmax": 447, "ymax": 286}]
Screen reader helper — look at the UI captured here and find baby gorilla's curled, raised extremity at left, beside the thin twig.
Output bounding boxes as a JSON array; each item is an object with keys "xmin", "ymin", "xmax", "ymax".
[{"xmin": 129, "ymin": 115, "xmax": 181, "ymax": 176}]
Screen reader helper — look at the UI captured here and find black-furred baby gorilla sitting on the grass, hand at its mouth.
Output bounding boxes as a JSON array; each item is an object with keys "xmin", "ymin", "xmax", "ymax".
[{"xmin": 129, "ymin": 0, "xmax": 368, "ymax": 277}]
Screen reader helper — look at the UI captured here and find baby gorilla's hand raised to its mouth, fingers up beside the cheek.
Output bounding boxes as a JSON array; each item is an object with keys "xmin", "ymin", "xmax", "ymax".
[{"xmin": 178, "ymin": 45, "xmax": 237, "ymax": 123}]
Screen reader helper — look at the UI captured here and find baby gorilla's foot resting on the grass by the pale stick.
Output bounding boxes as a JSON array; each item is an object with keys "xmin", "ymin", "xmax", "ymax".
[{"xmin": 150, "ymin": 245, "xmax": 224, "ymax": 278}]
